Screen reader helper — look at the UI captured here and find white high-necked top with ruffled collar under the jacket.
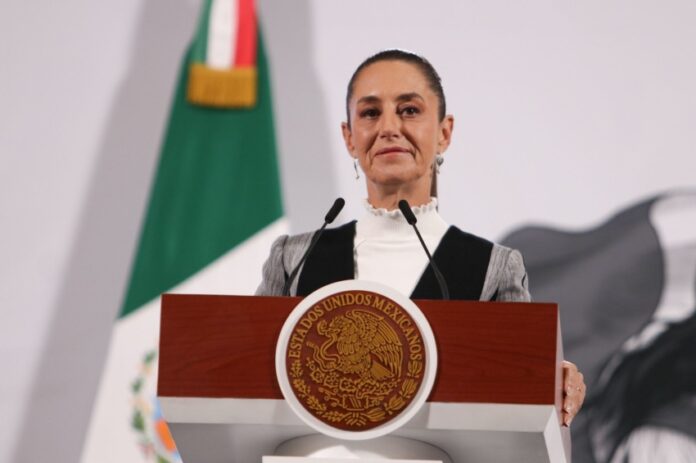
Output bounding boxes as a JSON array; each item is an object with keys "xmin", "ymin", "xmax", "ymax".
[{"xmin": 353, "ymin": 198, "xmax": 449, "ymax": 296}]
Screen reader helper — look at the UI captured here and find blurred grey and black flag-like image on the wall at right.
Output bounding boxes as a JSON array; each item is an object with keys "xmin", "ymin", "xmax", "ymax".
[{"xmin": 503, "ymin": 190, "xmax": 696, "ymax": 462}]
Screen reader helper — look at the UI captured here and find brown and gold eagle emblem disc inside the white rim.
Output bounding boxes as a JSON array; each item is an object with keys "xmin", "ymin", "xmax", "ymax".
[{"xmin": 286, "ymin": 292, "xmax": 425, "ymax": 431}]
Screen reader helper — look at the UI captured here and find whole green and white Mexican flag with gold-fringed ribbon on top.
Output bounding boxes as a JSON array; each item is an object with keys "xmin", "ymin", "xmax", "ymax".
[{"xmin": 82, "ymin": 0, "xmax": 286, "ymax": 463}]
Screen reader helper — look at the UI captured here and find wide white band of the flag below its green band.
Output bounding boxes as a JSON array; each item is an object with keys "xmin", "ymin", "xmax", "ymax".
[{"xmin": 81, "ymin": 218, "xmax": 288, "ymax": 463}]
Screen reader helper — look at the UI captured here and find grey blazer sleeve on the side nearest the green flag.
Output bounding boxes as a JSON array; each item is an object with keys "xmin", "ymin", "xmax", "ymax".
[{"xmin": 256, "ymin": 233, "xmax": 313, "ymax": 296}]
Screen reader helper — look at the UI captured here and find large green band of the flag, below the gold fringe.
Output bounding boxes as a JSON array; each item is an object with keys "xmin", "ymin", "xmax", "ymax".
[{"xmin": 121, "ymin": 29, "xmax": 283, "ymax": 316}]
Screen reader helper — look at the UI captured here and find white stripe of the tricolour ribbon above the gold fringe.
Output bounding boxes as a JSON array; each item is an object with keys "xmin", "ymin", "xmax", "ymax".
[{"xmin": 206, "ymin": 0, "xmax": 239, "ymax": 69}]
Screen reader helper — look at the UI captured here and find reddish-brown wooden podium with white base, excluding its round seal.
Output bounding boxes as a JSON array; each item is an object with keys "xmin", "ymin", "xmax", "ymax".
[{"xmin": 157, "ymin": 294, "xmax": 570, "ymax": 463}]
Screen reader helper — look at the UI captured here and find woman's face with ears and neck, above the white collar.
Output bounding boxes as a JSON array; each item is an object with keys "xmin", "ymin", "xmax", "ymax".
[{"xmin": 343, "ymin": 61, "xmax": 453, "ymax": 198}]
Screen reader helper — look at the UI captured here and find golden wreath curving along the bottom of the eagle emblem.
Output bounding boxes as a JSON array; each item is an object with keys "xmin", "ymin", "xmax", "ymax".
[{"xmin": 289, "ymin": 359, "xmax": 423, "ymax": 427}]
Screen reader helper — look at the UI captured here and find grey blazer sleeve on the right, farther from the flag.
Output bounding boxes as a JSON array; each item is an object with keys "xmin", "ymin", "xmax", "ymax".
[{"xmin": 481, "ymin": 244, "xmax": 532, "ymax": 302}]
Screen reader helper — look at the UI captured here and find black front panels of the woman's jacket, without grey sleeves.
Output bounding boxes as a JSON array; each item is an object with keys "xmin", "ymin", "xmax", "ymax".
[{"xmin": 297, "ymin": 221, "xmax": 493, "ymax": 301}]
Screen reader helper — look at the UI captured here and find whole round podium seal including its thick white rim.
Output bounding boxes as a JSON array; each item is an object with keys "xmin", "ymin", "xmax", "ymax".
[{"xmin": 276, "ymin": 280, "xmax": 437, "ymax": 440}]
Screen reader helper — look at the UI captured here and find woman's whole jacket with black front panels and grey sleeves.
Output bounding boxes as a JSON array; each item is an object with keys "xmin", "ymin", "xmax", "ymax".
[{"xmin": 256, "ymin": 221, "xmax": 531, "ymax": 302}]
